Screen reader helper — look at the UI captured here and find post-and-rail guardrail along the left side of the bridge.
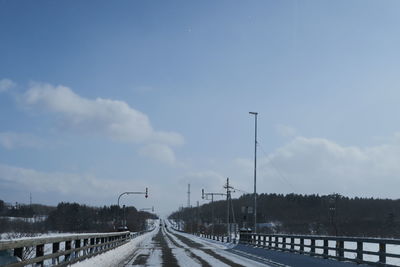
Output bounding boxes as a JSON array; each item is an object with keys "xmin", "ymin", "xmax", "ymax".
[{"xmin": 0, "ymin": 232, "xmax": 131, "ymax": 267}]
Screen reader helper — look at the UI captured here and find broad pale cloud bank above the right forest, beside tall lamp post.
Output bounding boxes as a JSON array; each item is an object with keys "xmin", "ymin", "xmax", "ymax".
[{"xmin": 241, "ymin": 137, "xmax": 400, "ymax": 198}]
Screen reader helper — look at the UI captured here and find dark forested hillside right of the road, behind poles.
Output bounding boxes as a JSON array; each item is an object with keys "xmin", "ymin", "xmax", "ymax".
[{"xmin": 170, "ymin": 194, "xmax": 400, "ymax": 238}]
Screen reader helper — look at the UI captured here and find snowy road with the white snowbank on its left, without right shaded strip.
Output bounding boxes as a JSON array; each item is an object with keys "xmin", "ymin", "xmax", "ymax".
[{"xmin": 74, "ymin": 223, "xmax": 268, "ymax": 267}]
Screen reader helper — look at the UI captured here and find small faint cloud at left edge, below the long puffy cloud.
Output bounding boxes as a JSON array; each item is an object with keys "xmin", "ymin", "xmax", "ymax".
[{"xmin": 0, "ymin": 132, "xmax": 43, "ymax": 149}]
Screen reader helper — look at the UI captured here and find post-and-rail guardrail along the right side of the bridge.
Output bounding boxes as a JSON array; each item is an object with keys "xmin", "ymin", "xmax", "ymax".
[{"xmin": 239, "ymin": 233, "xmax": 400, "ymax": 267}]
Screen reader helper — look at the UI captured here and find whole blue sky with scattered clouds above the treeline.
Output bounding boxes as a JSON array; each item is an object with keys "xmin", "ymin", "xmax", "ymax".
[{"xmin": 0, "ymin": 0, "xmax": 400, "ymax": 214}]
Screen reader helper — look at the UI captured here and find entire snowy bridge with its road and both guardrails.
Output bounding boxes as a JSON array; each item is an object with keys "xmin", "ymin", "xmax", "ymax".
[{"xmin": 0, "ymin": 221, "xmax": 400, "ymax": 267}]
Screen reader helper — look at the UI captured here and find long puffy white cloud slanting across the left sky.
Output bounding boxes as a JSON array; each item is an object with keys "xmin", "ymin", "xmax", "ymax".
[{"xmin": 23, "ymin": 83, "xmax": 184, "ymax": 161}]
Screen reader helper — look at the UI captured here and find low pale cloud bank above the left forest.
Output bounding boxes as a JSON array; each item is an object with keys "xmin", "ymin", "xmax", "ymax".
[{"xmin": 0, "ymin": 163, "xmax": 179, "ymax": 215}]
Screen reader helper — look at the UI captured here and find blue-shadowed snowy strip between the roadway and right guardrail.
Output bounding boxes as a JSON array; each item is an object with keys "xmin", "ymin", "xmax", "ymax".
[{"xmin": 231, "ymin": 244, "xmax": 368, "ymax": 267}]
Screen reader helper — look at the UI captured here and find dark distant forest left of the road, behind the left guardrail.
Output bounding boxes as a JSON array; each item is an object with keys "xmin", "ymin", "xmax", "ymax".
[{"xmin": 0, "ymin": 200, "xmax": 156, "ymax": 233}]
